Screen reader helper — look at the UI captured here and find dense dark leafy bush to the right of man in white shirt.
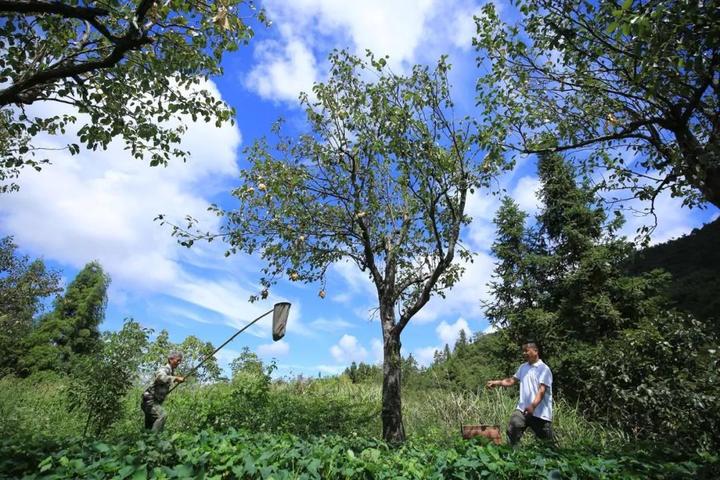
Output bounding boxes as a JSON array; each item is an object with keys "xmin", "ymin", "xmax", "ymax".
[{"xmin": 563, "ymin": 312, "xmax": 720, "ymax": 449}]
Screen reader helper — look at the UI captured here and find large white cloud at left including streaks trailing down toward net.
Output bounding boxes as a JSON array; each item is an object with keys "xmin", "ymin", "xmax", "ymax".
[{"xmin": 0, "ymin": 82, "xmax": 318, "ymax": 337}]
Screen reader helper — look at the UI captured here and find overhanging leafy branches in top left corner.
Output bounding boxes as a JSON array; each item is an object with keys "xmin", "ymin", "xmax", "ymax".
[{"xmin": 0, "ymin": 0, "xmax": 267, "ymax": 191}]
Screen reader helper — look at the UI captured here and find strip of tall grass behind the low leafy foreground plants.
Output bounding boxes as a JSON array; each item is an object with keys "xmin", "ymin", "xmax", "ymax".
[{"xmin": 0, "ymin": 376, "xmax": 627, "ymax": 447}]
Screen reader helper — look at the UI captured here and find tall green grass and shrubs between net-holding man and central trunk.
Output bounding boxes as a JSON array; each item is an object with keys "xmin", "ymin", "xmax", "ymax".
[{"xmin": 159, "ymin": 372, "xmax": 380, "ymax": 436}]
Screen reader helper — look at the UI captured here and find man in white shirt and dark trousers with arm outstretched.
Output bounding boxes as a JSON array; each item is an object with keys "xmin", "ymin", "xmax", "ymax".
[{"xmin": 486, "ymin": 342, "xmax": 555, "ymax": 446}]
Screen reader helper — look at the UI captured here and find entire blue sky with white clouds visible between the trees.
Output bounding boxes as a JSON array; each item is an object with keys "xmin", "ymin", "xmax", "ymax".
[{"xmin": 0, "ymin": 0, "xmax": 718, "ymax": 376}]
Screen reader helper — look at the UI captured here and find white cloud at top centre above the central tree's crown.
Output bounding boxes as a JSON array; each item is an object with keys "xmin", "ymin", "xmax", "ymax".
[{"xmin": 246, "ymin": 0, "xmax": 492, "ymax": 104}]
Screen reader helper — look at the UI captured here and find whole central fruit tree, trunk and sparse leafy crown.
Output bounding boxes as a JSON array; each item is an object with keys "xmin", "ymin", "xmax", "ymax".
[{"xmin": 164, "ymin": 48, "xmax": 497, "ymax": 441}]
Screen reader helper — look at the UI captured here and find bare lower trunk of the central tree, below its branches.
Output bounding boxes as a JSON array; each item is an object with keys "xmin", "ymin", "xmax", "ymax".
[{"xmin": 380, "ymin": 306, "xmax": 405, "ymax": 443}]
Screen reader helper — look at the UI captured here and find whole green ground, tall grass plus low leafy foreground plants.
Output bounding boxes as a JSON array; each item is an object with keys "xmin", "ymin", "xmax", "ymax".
[{"xmin": 0, "ymin": 376, "xmax": 719, "ymax": 479}]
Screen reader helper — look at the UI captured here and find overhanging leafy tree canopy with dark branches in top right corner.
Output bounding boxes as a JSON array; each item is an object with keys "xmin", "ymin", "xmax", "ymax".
[{"xmin": 475, "ymin": 0, "xmax": 720, "ymax": 210}]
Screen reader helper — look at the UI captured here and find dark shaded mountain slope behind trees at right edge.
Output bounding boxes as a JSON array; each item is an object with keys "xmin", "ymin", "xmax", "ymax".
[{"xmin": 630, "ymin": 218, "xmax": 720, "ymax": 326}]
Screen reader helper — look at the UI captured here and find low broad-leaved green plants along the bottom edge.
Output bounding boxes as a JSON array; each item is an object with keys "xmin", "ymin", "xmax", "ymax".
[{"xmin": 0, "ymin": 430, "xmax": 720, "ymax": 480}]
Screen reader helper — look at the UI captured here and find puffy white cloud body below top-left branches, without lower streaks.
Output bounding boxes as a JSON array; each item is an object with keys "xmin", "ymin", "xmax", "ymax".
[{"xmin": 0, "ymin": 83, "xmax": 240, "ymax": 290}]
